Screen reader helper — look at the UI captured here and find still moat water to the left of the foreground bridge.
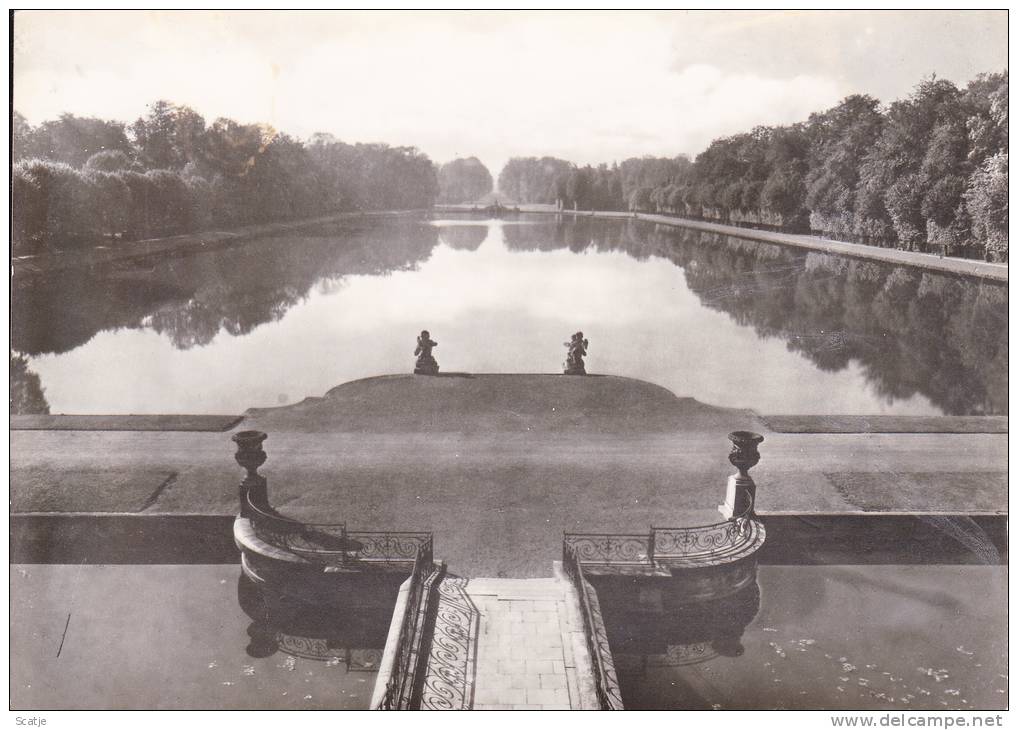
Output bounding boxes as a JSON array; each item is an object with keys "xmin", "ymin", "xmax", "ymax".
[{"xmin": 10, "ymin": 564, "xmax": 405, "ymax": 710}]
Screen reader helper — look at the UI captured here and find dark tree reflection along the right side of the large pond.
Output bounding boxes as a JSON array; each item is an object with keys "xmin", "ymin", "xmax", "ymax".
[{"xmin": 504, "ymin": 218, "xmax": 1008, "ymax": 414}]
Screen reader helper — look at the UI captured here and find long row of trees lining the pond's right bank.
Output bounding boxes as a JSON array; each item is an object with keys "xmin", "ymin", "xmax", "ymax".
[{"xmin": 499, "ymin": 71, "xmax": 1008, "ymax": 261}]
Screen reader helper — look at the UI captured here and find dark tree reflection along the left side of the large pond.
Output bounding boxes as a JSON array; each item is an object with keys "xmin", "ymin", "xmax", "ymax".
[{"xmin": 11, "ymin": 220, "xmax": 438, "ymax": 355}]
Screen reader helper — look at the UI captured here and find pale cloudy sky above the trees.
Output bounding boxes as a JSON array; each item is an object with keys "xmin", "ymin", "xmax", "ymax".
[{"xmin": 13, "ymin": 10, "xmax": 1008, "ymax": 176}]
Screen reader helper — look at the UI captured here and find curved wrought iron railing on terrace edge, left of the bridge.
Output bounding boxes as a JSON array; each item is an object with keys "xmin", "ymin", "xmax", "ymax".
[{"xmin": 246, "ymin": 497, "xmax": 432, "ymax": 565}]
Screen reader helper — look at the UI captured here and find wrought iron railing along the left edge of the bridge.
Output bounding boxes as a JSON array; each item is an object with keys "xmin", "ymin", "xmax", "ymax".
[{"xmin": 378, "ymin": 542, "xmax": 439, "ymax": 710}]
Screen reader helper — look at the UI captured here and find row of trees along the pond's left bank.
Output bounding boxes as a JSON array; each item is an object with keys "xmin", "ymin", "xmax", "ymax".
[{"xmin": 12, "ymin": 101, "xmax": 439, "ymax": 252}]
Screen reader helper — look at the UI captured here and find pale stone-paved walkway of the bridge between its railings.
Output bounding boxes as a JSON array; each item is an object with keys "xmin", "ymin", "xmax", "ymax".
[{"xmin": 421, "ymin": 577, "xmax": 597, "ymax": 710}]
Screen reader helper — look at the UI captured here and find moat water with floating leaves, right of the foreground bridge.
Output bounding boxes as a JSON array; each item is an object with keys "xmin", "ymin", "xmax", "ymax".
[{"xmin": 591, "ymin": 565, "xmax": 1008, "ymax": 710}]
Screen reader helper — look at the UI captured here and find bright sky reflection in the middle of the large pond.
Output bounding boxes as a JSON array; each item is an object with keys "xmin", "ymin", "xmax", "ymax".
[{"xmin": 32, "ymin": 222, "xmax": 939, "ymax": 414}]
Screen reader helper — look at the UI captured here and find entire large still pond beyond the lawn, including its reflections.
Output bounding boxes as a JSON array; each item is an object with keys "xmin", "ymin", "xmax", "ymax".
[{"xmin": 12, "ymin": 216, "xmax": 1007, "ymax": 414}]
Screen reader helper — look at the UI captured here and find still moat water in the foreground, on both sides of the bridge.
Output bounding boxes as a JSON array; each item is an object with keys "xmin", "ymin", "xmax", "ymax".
[{"xmin": 10, "ymin": 565, "xmax": 1008, "ymax": 711}]
